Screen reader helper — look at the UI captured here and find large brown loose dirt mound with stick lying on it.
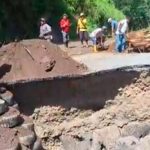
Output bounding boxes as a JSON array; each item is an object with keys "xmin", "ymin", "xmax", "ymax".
[{"xmin": 0, "ymin": 40, "xmax": 87, "ymax": 82}]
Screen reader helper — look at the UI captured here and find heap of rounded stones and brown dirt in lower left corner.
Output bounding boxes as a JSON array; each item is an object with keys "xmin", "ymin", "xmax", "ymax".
[{"xmin": 0, "ymin": 88, "xmax": 42, "ymax": 150}]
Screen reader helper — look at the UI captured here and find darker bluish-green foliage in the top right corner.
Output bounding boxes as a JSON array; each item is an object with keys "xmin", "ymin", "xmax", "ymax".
[{"xmin": 113, "ymin": 0, "xmax": 150, "ymax": 29}]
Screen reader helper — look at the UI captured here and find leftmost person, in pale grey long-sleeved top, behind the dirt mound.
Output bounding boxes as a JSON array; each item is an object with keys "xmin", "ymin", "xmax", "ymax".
[{"xmin": 39, "ymin": 18, "xmax": 52, "ymax": 41}]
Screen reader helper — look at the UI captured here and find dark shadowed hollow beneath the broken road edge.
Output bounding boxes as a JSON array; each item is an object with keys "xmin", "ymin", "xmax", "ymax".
[{"xmin": 4, "ymin": 70, "xmax": 140, "ymax": 115}]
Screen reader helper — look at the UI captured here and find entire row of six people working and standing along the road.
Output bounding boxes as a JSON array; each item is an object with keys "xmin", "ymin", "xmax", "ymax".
[{"xmin": 39, "ymin": 13, "xmax": 129, "ymax": 52}]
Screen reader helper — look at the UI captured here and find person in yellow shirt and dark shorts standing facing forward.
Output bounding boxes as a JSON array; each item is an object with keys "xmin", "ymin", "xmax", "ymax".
[{"xmin": 77, "ymin": 13, "xmax": 89, "ymax": 47}]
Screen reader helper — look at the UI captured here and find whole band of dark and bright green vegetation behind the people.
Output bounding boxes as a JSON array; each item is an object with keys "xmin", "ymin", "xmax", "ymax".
[{"xmin": 0, "ymin": 0, "xmax": 150, "ymax": 41}]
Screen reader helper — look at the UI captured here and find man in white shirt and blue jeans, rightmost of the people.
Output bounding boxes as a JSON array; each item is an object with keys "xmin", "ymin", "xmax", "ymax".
[{"xmin": 116, "ymin": 17, "xmax": 129, "ymax": 53}]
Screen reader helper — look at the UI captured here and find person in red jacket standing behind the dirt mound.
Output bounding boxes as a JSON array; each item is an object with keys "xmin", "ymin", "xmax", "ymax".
[{"xmin": 60, "ymin": 14, "xmax": 71, "ymax": 48}]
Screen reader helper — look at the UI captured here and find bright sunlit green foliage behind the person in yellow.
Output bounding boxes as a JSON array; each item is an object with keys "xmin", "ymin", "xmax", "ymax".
[{"xmin": 65, "ymin": 0, "xmax": 124, "ymax": 31}]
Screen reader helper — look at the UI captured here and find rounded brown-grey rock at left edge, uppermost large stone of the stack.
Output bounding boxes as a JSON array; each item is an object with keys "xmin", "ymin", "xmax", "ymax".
[{"xmin": 0, "ymin": 91, "xmax": 14, "ymax": 106}]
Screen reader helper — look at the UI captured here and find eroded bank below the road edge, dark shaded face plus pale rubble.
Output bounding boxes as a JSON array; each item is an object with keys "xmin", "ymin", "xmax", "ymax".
[{"xmin": 1, "ymin": 68, "xmax": 150, "ymax": 150}]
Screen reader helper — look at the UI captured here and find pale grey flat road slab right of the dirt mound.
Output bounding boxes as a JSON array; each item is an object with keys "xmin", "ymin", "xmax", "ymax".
[{"xmin": 72, "ymin": 52, "xmax": 150, "ymax": 72}]
